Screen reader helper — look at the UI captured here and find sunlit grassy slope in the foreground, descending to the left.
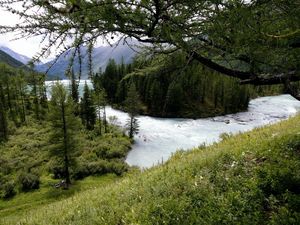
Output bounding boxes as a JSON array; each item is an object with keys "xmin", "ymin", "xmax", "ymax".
[{"xmin": 0, "ymin": 116, "xmax": 300, "ymax": 225}]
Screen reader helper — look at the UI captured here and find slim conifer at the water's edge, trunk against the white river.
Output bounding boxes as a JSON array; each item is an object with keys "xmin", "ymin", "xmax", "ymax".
[{"xmin": 124, "ymin": 83, "xmax": 141, "ymax": 138}]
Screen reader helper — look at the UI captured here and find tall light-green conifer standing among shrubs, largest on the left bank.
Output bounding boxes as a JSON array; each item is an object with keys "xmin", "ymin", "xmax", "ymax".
[{"xmin": 49, "ymin": 83, "xmax": 78, "ymax": 188}]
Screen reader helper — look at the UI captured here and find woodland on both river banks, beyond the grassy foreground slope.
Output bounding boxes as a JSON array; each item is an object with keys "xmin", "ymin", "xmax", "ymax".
[{"xmin": 0, "ymin": 51, "xmax": 281, "ymax": 199}]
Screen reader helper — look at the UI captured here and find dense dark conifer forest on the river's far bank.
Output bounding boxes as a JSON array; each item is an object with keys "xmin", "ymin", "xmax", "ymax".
[{"xmin": 93, "ymin": 53, "xmax": 283, "ymax": 118}]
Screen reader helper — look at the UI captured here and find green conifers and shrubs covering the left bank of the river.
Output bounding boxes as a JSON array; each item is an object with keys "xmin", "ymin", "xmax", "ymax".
[{"xmin": 0, "ymin": 64, "xmax": 131, "ymax": 199}]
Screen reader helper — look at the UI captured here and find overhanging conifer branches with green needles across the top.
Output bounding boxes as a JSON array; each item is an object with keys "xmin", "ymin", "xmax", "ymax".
[{"xmin": 0, "ymin": 0, "xmax": 300, "ymax": 99}]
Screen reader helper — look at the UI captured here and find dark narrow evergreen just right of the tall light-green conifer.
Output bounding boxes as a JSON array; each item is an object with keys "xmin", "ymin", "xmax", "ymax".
[{"xmin": 80, "ymin": 82, "xmax": 96, "ymax": 130}]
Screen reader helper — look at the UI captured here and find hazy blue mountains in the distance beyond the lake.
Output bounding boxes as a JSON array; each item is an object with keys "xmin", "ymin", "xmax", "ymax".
[{"xmin": 35, "ymin": 40, "xmax": 136, "ymax": 78}]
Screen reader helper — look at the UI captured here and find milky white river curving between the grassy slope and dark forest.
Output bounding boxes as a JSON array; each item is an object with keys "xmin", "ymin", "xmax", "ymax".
[{"xmin": 47, "ymin": 81, "xmax": 300, "ymax": 168}]
